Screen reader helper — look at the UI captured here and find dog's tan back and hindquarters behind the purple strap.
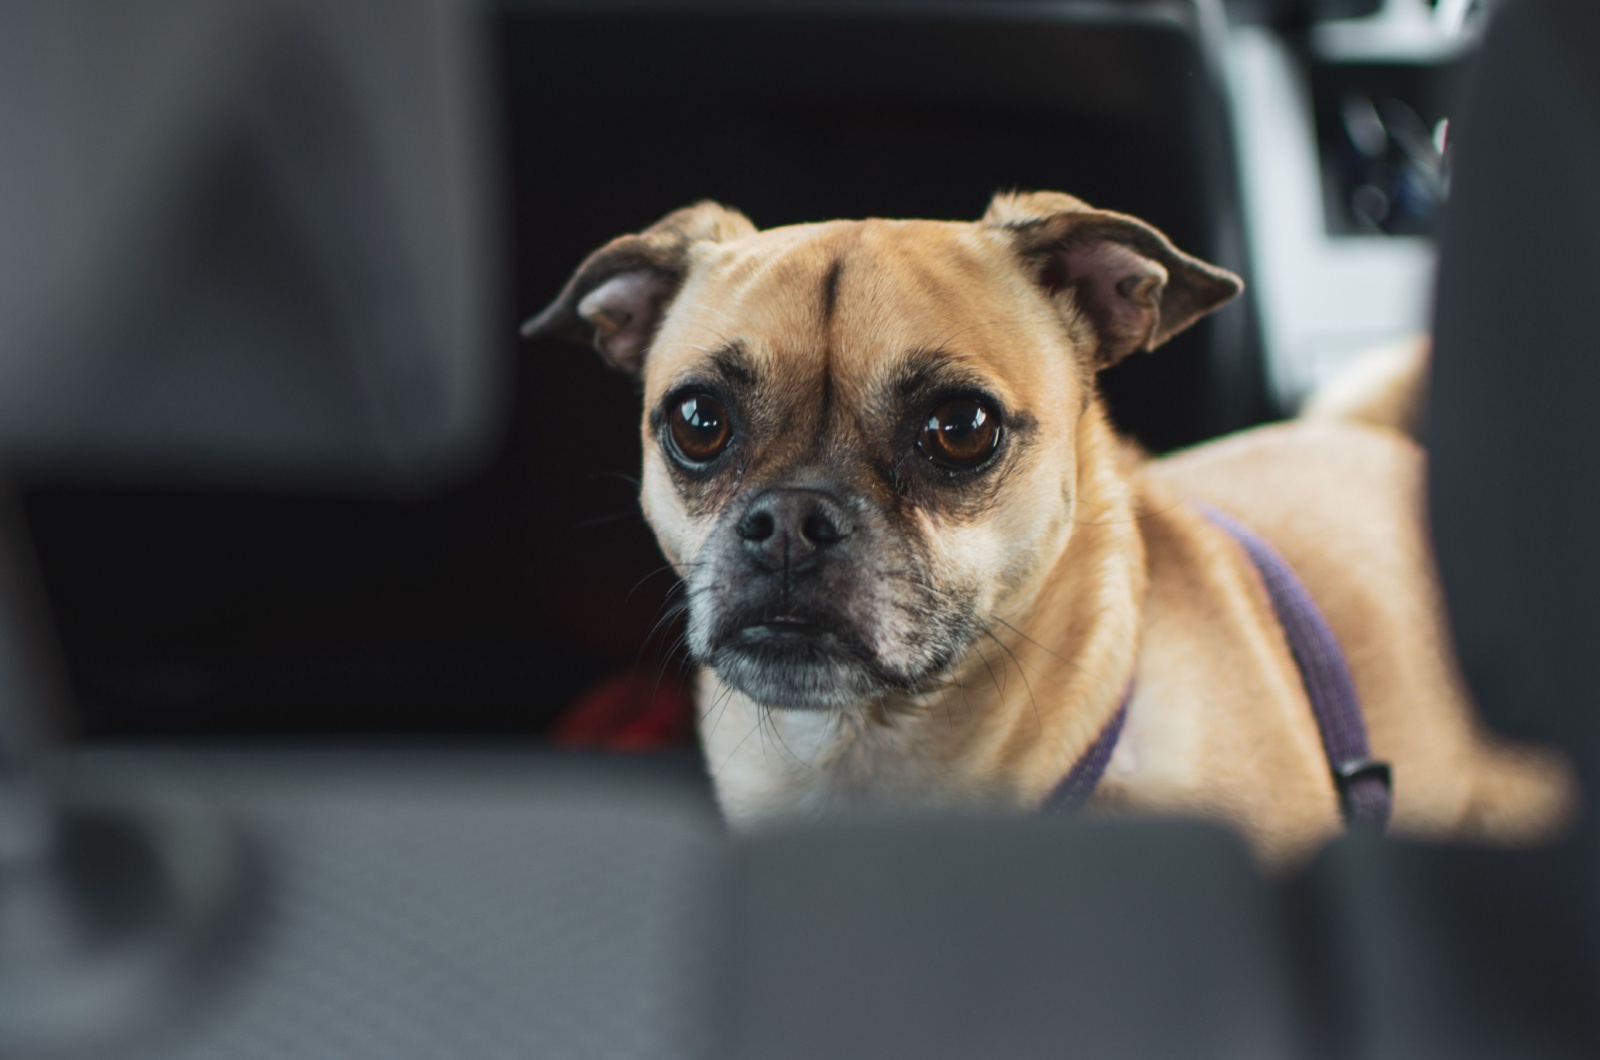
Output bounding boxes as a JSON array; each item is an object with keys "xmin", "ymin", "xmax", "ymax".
[{"xmin": 1141, "ymin": 403, "xmax": 1576, "ymax": 842}]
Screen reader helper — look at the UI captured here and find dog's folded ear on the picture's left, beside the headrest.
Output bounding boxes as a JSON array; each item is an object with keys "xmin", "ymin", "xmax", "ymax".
[{"xmin": 522, "ymin": 202, "xmax": 755, "ymax": 375}]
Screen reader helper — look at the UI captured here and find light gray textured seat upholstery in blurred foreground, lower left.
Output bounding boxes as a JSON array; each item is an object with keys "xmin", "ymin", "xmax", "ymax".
[{"xmin": 56, "ymin": 753, "xmax": 726, "ymax": 1060}]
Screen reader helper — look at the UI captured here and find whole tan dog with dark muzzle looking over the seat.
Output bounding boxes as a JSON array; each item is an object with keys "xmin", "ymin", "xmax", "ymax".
[{"xmin": 525, "ymin": 194, "xmax": 1573, "ymax": 863}]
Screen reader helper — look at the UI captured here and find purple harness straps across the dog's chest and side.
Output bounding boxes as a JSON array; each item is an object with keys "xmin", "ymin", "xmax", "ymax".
[{"xmin": 1045, "ymin": 506, "xmax": 1394, "ymax": 831}]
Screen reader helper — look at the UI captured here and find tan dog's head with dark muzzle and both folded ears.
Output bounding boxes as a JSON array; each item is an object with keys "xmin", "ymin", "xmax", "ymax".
[{"xmin": 525, "ymin": 192, "xmax": 1240, "ymax": 709}]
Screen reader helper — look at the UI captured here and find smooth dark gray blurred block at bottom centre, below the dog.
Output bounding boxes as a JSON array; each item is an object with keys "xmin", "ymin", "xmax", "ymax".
[{"xmin": 726, "ymin": 817, "xmax": 1298, "ymax": 1060}]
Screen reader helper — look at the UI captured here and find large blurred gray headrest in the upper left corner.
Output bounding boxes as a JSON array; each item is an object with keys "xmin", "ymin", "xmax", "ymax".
[{"xmin": 0, "ymin": 0, "xmax": 509, "ymax": 484}]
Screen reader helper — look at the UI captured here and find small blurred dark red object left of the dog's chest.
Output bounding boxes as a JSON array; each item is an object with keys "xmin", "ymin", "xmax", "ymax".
[{"xmin": 549, "ymin": 668, "xmax": 693, "ymax": 751}]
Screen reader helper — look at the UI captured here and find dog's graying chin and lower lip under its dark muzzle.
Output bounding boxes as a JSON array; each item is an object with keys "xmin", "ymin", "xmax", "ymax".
[{"xmin": 707, "ymin": 623, "xmax": 901, "ymax": 711}]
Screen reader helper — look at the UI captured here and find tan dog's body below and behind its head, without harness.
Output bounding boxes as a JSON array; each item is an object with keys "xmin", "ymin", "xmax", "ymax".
[{"xmin": 699, "ymin": 409, "xmax": 1568, "ymax": 863}]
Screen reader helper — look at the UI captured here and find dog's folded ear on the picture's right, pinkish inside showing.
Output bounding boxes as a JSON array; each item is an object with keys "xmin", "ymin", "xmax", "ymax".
[{"xmin": 982, "ymin": 192, "xmax": 1245, "ymax": 368}]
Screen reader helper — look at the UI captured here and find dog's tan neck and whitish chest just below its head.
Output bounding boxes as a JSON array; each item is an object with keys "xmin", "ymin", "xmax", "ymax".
[{"xmin": 699, "ymin": 402, "xmax": 1146, "ymax": 825}]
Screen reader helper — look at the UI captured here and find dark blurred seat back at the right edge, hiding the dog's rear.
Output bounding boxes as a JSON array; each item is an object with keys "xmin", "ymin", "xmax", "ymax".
[{"xmin": 1427, "ymin": 0, "xmax": 1600, "ymax": 793}]
